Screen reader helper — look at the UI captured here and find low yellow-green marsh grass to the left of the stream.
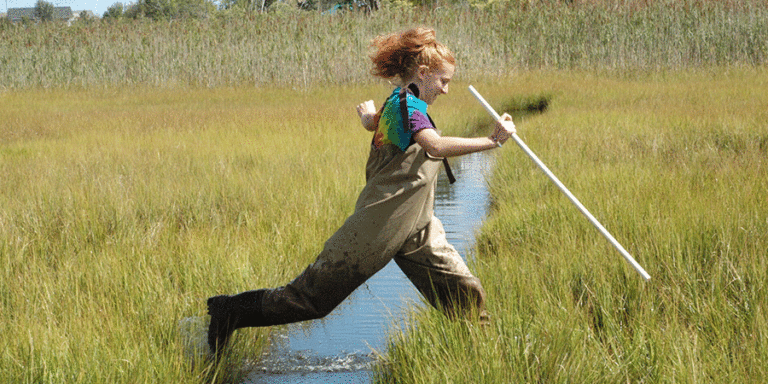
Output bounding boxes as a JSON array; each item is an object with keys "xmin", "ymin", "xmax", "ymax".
[{"xmin": 0, "ymin": 84, "xmax": 396, "ymax": 383}]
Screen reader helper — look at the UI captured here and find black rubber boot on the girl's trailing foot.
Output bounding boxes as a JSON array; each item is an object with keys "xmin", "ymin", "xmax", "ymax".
[{"xmin": 208, "ymin": 290, "xmax": 266, "ymax": 358}]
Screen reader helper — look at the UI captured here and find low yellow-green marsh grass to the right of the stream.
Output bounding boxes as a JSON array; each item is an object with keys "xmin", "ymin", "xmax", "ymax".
[{"xmin": 379, "ymin": 69, "xmax": 768, "ymax": 383}]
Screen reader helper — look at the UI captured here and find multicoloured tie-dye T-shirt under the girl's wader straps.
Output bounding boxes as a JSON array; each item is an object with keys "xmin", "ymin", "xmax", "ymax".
[{"xmin": 373, "ymin": 88, "xmax": 434, "ymax": 151}]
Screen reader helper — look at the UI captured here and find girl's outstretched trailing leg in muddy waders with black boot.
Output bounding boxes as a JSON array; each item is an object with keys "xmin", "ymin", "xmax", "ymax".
[{"xmin": 208, "ymin": 208, "xmax": 407, "ymax": 352}]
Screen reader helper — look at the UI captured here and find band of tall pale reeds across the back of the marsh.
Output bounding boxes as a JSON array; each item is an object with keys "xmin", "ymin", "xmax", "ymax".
[{"xmin": 0, "ymin": 0, "xmax": 768, "ymax": 89}]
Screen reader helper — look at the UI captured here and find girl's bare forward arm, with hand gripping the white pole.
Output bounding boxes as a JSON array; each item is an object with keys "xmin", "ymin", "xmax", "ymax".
[{"xmin": 413, "ymin": 113, "xmax": 516, "ymax": 157}]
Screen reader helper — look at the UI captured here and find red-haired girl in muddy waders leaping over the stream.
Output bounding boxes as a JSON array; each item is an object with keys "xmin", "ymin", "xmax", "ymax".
[{"xmin": 208, "ymin": 28, "xmax": 515, "ymax": 355}]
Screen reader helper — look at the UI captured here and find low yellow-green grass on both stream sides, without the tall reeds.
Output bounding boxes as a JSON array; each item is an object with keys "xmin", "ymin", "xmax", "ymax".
[{"xmin": 0, "ymin": 68, "xmax": 768, "ymax": 383}]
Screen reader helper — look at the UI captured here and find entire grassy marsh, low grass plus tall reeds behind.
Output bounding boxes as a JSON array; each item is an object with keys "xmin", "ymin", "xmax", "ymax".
[{"xmin": 0, "ymin": 0, "xmax": 768, "ymax": 383}]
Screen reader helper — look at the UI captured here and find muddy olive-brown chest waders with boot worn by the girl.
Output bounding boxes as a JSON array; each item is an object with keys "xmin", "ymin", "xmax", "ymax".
[{"xmin": 208, "ymin": 88, "xmax": 485, "ymax": 356}]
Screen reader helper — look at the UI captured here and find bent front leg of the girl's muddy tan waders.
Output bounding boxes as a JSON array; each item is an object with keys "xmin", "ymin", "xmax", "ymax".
[{"xmin": 395, "ymin": 217, "xmax": 488, "ymax": 322}]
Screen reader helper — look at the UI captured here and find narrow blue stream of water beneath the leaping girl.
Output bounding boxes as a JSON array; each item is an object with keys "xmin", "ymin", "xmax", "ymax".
[{"xmin": 243, "ymin": 154, "xmax": 492, "ymax": 384}]
